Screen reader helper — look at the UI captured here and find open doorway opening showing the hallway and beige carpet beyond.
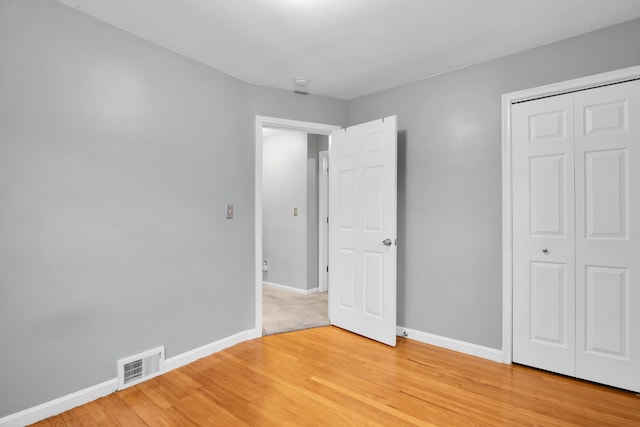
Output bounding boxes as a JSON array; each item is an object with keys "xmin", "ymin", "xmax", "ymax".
[{"xmin": 262, "ymin": 128, "xmax": 329, "ymax": 335}]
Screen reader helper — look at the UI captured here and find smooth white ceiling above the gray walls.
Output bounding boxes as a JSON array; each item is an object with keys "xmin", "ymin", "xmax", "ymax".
[{"xmin": 58, "ymin": 0, "xmax": 640, "ymax": 100}]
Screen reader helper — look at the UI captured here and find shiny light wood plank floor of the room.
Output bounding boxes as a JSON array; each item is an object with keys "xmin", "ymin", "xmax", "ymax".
[{"xmin": 37, "ymin": 327, "xmax": 640, "ymax": 426}]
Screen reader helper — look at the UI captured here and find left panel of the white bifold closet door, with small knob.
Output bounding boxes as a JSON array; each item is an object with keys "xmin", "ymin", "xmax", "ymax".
[{"xmin": 511, "ymin": 95, "xmax": 575, "ymax": 375}]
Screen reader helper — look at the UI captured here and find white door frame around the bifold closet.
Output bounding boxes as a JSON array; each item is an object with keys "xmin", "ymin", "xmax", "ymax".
[{"xmin": 502, "ymin": 66, "xmax": 640, "ymax": 363}]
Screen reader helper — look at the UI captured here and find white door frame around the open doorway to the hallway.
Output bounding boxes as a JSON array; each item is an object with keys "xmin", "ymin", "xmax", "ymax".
[{"xmin": 254, "ymin": 116, "xmax": 340, "ymax": 336}]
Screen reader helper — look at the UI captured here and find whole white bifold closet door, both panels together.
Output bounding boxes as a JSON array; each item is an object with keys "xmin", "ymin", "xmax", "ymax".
[{"xmin": 511, "ymin": 81, "xmax": 640, "ymax": 391}]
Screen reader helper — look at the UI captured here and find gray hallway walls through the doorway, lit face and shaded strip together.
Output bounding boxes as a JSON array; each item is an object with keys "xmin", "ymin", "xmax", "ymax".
[{"xmin": 262, "ymin": 131, "xmax": 328, "ymax": 290}]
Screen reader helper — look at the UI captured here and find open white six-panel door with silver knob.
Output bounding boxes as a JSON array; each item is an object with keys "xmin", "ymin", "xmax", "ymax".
[{"xmin": 329, "ymin": 116, "xmax": 397, "ymax": 346}]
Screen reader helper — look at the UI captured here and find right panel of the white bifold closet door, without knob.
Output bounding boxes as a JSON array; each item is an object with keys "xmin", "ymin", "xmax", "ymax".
[{"xmin": 574, "ymin": 81, "xmax": 640, "ymax": 391}]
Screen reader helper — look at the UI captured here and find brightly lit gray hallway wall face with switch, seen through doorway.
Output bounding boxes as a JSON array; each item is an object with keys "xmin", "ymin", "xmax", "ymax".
[{"xmin": 262, "ymin": 131, "xmax": 307, "ymax": 289}]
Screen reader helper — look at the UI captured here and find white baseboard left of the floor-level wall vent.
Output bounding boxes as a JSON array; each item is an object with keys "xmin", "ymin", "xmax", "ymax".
[{"xmin": 0, "ymin": 378, "xmax": 118, "ymax": 427}]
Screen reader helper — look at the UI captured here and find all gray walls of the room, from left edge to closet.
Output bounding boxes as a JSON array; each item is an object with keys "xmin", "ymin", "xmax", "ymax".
[{"xmin": 0, "ymin": 0, "xmax": 640, "ymax": 417}]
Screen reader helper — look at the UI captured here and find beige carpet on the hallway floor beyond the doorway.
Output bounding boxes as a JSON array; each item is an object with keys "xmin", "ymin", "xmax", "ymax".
[{"xmin": 262, "ymin": 286, "xmax": 329, "ymax": 335}]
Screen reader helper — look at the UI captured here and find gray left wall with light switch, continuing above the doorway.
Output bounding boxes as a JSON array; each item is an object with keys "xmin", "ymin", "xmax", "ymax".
[{"xmin": 0, "ymin": 0, "xmax": 347, "ymax": 417}]
